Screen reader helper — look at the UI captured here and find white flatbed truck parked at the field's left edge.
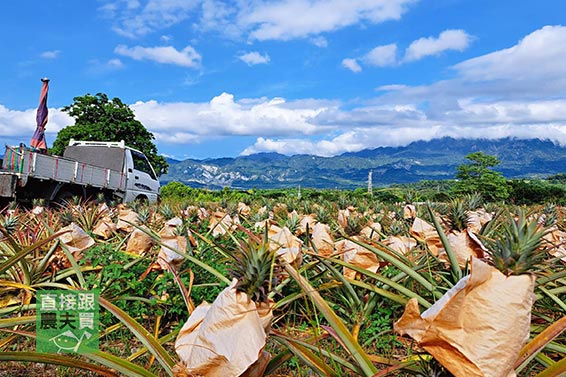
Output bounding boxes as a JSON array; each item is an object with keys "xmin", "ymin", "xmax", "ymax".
[{"xmin": 0, "ymin": 139, "xmax": 159, "ymax": 203}]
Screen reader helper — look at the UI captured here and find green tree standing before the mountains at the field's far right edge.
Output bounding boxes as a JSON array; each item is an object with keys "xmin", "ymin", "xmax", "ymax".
[{"xmin": 454, "ymin": 152, "xmax": 509, "ymax": 201}]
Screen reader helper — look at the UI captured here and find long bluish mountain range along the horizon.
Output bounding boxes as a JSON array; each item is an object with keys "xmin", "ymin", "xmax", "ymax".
[{"xmin": 160, "ymin": 137, "xmax": 566, "ymax": 189}]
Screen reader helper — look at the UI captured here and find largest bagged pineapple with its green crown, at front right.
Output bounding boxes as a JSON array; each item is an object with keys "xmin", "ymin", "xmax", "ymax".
[{"xmin": 395, "ymin": 211, "xmax": 545, "ymax": 376}]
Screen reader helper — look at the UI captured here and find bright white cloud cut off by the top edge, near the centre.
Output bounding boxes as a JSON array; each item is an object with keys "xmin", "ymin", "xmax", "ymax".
[{"xmin": 245, "ymin": 0, "xmax": 415, "ymax": 40}]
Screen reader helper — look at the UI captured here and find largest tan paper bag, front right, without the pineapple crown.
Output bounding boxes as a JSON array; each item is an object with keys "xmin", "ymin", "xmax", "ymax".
[{"xmin": 394, "ymin": 258, "xmax": 535, "ymax": 377}]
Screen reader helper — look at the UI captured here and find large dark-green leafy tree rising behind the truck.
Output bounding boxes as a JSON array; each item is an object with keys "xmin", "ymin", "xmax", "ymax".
[{"xmin": 51, "ymin": 93, "xmax": 168, "ymax": 175}]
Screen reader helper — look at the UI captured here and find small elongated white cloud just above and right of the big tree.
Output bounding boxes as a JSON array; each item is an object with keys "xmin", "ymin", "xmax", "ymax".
[{"xmin": 114, "ymin": 45, "xmax": 201, "ymax": 68}]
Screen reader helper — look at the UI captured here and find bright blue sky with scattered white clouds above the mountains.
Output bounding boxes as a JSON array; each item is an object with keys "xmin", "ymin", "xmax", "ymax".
[{"xmin": 0, "ymin": 0, "xmax": 566, "ymax": 159}]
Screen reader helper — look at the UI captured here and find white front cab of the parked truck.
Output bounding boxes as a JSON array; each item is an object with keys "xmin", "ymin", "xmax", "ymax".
[{"xmin": 125, "ymin": 149, "xmax": 159, "ymax": 202}]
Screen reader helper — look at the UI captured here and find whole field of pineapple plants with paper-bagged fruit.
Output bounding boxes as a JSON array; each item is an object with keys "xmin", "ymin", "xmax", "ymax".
[{"xmin": 0, "ymin": 190, "xmax": 566, "ymax": 377}]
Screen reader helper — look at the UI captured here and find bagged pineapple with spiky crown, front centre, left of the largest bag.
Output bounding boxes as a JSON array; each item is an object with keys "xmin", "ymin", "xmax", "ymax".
[{"xmin": 174, "ymin": 233, "xmax": 275, "ymax": 377}]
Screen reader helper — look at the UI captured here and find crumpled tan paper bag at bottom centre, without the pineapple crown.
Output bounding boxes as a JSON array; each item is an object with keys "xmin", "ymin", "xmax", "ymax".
[{"xmin": 175, "ymin": 279, "xmax": 272, "ymax": 377}]
